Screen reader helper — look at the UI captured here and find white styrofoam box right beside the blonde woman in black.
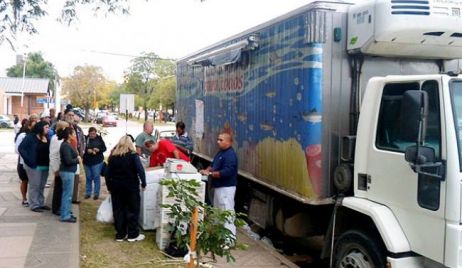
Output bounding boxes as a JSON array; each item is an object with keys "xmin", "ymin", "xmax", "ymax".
[{"xmin": 138, "ymin": 169, "xmax": 164, "ymax": 230}]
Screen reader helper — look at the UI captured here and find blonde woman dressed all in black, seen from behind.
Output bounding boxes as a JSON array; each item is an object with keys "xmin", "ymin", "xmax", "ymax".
[{"xmin": 106, "ymin": 136, "xmax": 146, "ymax": 242}]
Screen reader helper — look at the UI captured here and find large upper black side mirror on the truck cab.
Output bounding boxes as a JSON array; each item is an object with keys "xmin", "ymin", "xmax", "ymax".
[{"xmin": 400, "ymin": 90, "xmax": 428, "ymax": 141}]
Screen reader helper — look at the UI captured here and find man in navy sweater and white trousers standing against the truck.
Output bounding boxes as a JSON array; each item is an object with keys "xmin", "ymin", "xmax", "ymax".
[{"xmin": 200, "ymin": 132, "xmax": 237, "ymax": 237}]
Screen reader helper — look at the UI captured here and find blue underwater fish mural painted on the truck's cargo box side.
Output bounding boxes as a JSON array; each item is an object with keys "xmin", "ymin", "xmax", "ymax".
[{"xmin": 177, "ymin": 14, "xmax": 327, "ymax": 200}]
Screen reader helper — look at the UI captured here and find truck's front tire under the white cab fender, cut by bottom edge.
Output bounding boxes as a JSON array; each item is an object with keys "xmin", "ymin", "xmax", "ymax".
[{"xmin": 334, "ymin": 230, "xmax": 386, "ymax": 268}]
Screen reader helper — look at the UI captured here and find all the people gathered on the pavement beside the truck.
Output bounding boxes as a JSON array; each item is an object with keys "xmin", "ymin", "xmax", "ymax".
[{"xmin": 15, "ymin": 112, "xmax": 238, "ymax": 242}]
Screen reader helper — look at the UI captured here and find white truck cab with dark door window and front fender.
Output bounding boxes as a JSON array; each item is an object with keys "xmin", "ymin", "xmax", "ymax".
[{"xmin": 343, "ymin": 75, "xmax": 462, "ymax": 267}]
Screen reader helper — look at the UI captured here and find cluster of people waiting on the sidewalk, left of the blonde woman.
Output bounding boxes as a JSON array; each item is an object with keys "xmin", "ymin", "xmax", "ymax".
[{"xmin": 15, "ymin": 106, "xmax": 106, "ymax": 223}]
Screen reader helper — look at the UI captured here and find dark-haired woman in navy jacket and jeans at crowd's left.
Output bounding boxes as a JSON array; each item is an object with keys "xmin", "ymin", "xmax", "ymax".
[{"xmin": 18, "ymin": 121, "xmax": 50, "ymax": 212}]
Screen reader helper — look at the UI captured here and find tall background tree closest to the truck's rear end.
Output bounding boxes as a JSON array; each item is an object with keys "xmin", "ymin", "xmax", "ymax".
[{"xmin": 125, "ymin": 52, "xmax": 175, "ymax": 120}]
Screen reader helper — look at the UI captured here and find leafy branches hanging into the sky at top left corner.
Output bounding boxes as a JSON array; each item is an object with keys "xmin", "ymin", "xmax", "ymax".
[{"xmin": 0, "ymin": 0, "xmax": 133, "ymax": 49}]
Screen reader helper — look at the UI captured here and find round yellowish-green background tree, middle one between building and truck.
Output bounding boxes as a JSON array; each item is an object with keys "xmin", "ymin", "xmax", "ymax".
[{"xmin": 63, "ymin": 65, "xmax": 108, "ymax": 121}]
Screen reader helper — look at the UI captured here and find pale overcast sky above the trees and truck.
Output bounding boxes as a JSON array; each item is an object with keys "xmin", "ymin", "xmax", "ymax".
[{"xmin": 0, "ymin": 0, "xmax": 310, "ymax": 82}]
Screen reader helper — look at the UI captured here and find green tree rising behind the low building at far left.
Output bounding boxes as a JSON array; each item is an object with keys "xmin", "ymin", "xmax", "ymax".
[{"xmin": 6, "ymin": 52, "xmax": 58, "ymax": 90}]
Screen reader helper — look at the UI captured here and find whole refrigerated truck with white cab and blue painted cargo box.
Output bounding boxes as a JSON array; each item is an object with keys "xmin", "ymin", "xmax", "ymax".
[{"xmin": 176, "ymin": 0, "xmax": 462, "ymax": 267}]
